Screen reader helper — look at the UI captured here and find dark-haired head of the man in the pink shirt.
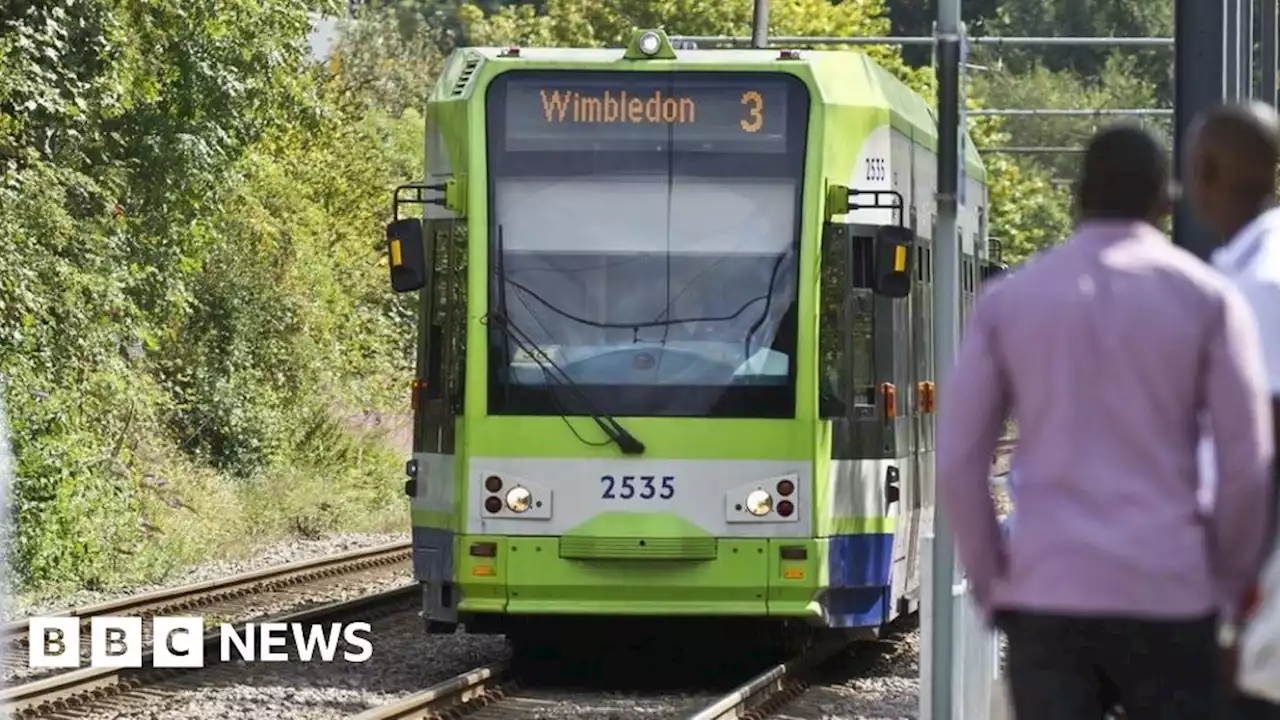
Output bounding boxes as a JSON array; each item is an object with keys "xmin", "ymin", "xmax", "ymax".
[{"xmin": 1075, "ymin": 123, "xmax": 1171, "ymax": 224}]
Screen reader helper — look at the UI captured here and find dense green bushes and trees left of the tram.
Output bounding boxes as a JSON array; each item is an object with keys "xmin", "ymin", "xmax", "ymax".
[{"xmin": 0, "ymin": 0, "xmax": 421, "ymax": 587}]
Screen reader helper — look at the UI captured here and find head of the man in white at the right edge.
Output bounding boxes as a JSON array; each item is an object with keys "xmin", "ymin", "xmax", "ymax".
[{"xmin": 1188, "ymin": 102, "xmax": 1280, "ymax": 241}]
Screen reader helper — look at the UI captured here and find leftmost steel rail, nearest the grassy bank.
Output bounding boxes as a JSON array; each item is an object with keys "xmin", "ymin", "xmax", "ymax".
[{"xmin": 0, "ymin": 541, "xmax": 412, "ymax": 642}]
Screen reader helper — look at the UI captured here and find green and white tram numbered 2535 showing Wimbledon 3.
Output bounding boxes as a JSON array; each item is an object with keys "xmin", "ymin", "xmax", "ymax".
[{"xmin": 387, "ymin": 31, "xmax": 996, "ymax": 635}]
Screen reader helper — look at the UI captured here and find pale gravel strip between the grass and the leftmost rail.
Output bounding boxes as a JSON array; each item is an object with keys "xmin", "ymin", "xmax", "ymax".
[{"xmin": 0, "ymin": 533, "xmax": 408, "ymax": 621}]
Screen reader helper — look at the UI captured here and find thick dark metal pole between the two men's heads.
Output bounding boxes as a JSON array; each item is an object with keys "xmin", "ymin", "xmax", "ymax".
[{"xmin": 1174, "ymin": 0, "xmax": 1226, "ymax": 258}]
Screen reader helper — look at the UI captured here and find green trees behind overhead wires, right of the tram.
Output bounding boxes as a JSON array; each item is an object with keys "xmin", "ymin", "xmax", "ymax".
[{"xmin": 888, "ymin": 0, "xmax": 1172, "ymax": 260}]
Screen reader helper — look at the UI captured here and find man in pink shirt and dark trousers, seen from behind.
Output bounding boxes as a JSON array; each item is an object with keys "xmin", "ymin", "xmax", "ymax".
[{"xmin": 937, "ymin": 126, "xmax": 1274, "ymax": 720}]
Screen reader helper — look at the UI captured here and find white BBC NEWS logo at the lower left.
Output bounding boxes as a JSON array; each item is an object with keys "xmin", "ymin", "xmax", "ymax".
[{"xmin": 27, "ymin": 618, "xmax": 374, "ymax": 667}]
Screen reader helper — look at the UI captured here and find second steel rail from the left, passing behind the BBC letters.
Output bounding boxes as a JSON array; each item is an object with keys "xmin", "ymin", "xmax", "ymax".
[{"xmin": 0, "ymin": 584, "xmax": 420, "ymax": 717}]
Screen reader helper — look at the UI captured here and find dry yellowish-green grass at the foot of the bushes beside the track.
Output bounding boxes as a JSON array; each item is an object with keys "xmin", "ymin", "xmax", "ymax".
[{"xmin": 12, "ymin": 419, "xmax": 408, "ymax": 607}]
